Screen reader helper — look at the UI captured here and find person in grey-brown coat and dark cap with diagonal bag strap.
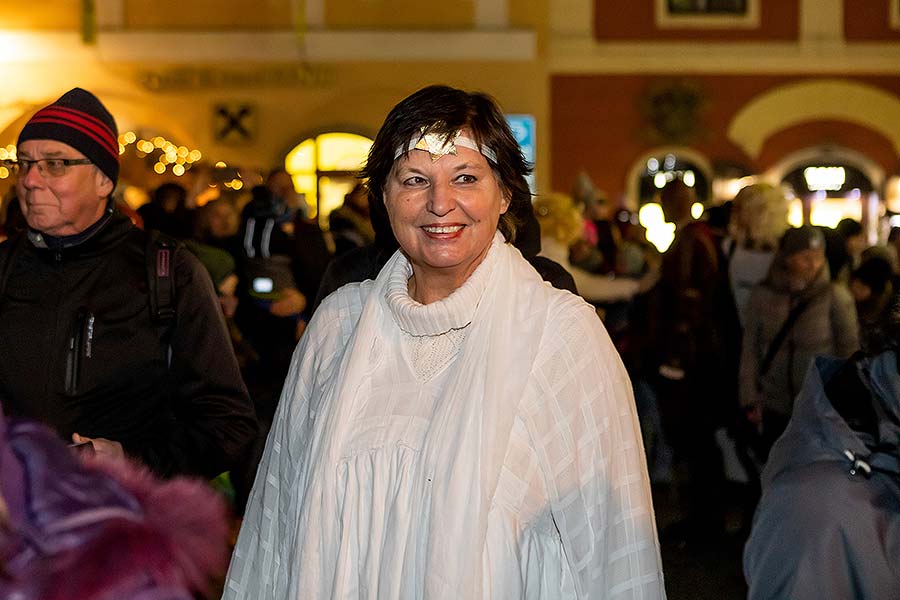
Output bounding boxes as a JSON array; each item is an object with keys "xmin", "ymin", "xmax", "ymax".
[{"xmin": 739, "ymin": 225, "xmax": 859, "ymax": 462}]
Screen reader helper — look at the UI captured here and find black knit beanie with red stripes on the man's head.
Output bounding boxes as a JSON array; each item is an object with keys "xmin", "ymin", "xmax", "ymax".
[{"xmin": 18, "ymin": 88, "xmax": 119, "ymax": 185}]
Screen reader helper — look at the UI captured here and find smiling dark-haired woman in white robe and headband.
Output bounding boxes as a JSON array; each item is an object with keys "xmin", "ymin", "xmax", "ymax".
[{"xmin": 224, "ymin": 86, "xmax": 665, "ymax": 599}]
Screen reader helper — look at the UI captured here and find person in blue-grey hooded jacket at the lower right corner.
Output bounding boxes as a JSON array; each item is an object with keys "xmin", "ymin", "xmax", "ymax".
[{"xmin": 744, "ymin": 294, "xmax": 900, "ymax": 600}]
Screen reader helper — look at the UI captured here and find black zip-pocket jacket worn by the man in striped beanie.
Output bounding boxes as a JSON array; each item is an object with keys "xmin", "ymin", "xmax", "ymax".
[{"xmin": 0, "ymin": 212, "xmax": 257, "ymax": 477}]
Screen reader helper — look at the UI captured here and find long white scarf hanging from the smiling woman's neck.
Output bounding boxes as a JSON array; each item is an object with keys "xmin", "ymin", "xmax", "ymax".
[{"xmin": 291, "ymin": 234, "xmax": 556, "ymax": 598}]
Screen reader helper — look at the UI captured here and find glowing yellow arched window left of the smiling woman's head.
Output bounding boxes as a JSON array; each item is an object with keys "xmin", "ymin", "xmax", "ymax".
[{"xmin": 284, "ymin": 132, "xmax": 372, "ymax": 229}]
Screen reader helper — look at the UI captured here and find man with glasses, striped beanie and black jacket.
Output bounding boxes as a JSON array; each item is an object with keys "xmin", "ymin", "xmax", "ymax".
[{"xmin": 0, "ymin": 88, "xmax": 256, "ymax": 488}]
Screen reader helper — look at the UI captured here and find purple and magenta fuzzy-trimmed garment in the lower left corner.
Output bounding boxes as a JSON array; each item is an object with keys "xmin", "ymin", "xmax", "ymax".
[{"xmin": 0, "ymin": 423, "xmax": 228, "ymax": 600}]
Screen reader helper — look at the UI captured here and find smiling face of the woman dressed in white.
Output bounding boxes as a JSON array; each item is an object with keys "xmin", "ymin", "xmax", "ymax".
[{"xmin": 384, "ymin": 146, "xmax": 509, "ymax": 295}]
